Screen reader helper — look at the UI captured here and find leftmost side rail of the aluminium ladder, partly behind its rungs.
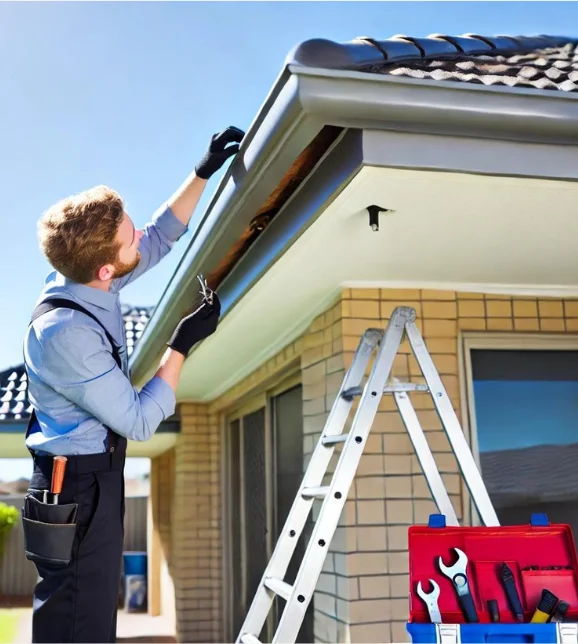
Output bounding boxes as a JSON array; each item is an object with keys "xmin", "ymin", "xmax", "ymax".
[{"xmin": 236, "ymin": 329, "xmax": 383, "ymax": 644}]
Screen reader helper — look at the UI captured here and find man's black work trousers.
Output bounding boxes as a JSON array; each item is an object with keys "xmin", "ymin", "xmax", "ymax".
[{"xmin": 25, "ymin": 450, "xmax": 125, "ymax": 642}]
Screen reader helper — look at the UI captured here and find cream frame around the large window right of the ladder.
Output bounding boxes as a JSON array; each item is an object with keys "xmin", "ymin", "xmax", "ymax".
[{"xmin": 458, "ymin": 331, "xmax": 578, "ymax": 526}]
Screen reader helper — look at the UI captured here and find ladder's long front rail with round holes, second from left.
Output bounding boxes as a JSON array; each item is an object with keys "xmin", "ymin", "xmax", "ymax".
[{"xmin": 272, "ymin": 307, "xmax": 415, "ymax": 644}]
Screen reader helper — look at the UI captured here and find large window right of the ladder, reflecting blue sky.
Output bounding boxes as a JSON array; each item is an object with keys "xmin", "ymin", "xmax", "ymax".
[{"xmin": 465, "ymin": 336, "xmax": 578, "ymax": 535}]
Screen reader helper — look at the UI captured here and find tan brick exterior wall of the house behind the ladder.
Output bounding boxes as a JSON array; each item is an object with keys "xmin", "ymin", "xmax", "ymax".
[{"xmin": 160, "ymin": 289, "xmax": 578, "ymax": 642}]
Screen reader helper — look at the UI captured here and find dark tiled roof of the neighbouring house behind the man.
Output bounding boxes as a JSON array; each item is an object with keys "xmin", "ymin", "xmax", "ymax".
[{"xmin": 0, "ymin": 305, "xmax": 153, "ymax": 422}]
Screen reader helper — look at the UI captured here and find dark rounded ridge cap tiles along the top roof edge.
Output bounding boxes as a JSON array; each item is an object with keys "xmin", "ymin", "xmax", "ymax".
[{"xmin": 285, "ymin": 33, "xmax": 578, "ymax": 70}]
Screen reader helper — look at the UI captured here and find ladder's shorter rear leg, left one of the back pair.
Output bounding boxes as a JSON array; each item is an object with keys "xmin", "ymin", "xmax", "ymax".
[{"xmin": 393, "ymin": 384, "xmax": 460, "ymax": 526}]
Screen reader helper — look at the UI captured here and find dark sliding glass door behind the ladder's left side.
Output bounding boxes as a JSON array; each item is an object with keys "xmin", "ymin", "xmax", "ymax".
[{"xmin": 225, "ymin": 384, "xmax": 313, "ymax": 643}]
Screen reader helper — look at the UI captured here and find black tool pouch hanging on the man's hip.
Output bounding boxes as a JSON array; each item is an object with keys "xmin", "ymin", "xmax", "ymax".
[{"xmin": 22, "ymin": 494, "xmax": 78, "ymax": 566}]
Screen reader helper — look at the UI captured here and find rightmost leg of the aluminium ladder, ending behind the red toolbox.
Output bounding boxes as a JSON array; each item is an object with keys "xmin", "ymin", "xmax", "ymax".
[{"xmin": 406, "ymin": 323, "xmax": 500, "ymax": 526}]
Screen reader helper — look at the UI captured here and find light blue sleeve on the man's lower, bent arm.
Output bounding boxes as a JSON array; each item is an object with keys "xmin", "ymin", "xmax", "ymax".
[{"xmin": 37, "ymin": 325, "xmax": 176, "ymax": 441}]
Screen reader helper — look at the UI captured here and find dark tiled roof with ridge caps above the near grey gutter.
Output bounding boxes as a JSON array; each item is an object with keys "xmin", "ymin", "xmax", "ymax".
[{"xmin": 288, "ymin": 34, "xmax": 578, "ymax": 92}]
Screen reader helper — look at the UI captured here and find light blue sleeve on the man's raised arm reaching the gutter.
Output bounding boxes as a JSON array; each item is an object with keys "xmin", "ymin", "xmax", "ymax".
[{"xmin": 110, "ymin": 206, "xmax": 187, "ymax": 292}]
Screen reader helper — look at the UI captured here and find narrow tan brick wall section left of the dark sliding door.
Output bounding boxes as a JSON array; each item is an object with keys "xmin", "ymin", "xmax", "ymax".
[{"xmin": 171, "ymin": 404, "xmax": 223, "ymax": 642}]
